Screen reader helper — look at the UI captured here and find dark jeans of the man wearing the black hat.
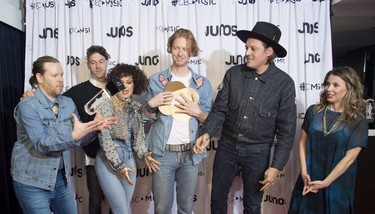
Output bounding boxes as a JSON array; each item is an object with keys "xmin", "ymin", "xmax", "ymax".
[{"xmin": 211, "ymin": 138, "xmax": 270, "ymax": 214}]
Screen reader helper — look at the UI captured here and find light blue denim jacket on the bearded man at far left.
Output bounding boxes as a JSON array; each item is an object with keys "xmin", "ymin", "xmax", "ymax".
[{"xmin": 11, "ymin": 89, "xmax": 95, "ymax": 190}]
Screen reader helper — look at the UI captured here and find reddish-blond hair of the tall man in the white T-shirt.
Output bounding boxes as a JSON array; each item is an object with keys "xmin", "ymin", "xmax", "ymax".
[{"xmin": 167, "ymin": 28, "xmax": 200, "ymax": 56}]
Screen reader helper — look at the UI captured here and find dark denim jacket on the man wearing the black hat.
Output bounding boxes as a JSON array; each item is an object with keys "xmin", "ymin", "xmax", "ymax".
[{"xmin": 202, "ymin": 62, "xmax": 297, "ymax": 170}]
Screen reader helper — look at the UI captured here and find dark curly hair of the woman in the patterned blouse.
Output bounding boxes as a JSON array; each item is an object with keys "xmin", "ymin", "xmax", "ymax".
[{"xmin": 107, "ymin": 63, "xmax": 148, "ymax": 95}]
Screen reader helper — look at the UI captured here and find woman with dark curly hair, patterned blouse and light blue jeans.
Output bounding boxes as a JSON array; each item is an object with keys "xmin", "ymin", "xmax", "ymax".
[{"xmin": 95, "ymin": 63, "xmax": 159, "ymax": 213}]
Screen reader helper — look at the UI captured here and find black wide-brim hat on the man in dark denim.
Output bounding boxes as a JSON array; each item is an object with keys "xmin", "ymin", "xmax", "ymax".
[{"xmin": 237, "ymin": 22, "xmax": 287, "ymax": 57}]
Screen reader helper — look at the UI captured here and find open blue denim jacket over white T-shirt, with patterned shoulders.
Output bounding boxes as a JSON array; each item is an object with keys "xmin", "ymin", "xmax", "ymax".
[{"xmin": 146, "ymin": 68, "xmax": 212, "ymax": 164}]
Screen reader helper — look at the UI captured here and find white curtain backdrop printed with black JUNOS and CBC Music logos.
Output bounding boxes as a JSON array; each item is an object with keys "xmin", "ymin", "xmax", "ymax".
[{"xmin": 25, "ymin": 0, "xmax": 332, "ymax": 214}]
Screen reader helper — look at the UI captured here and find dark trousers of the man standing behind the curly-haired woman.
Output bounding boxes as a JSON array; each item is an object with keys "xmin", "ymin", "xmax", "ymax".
[{"xmin": 86, "ymin": 165, "xmax": 104, "ymax": 214}]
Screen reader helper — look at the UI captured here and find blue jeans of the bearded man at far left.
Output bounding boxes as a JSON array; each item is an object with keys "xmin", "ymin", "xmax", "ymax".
[{"xmin": 13, "ymin": 171, "xmax": 77, "ymax": 214}]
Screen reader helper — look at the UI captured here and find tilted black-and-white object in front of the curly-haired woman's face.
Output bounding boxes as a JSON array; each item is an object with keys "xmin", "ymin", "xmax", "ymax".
[{"xmin": 85, "ymin": 77, "xmax": 125, "ymax": 115}]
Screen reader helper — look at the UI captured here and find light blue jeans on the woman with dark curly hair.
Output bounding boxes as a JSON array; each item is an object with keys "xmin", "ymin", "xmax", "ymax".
[{"xmin": 95, "ymin": 144, "xmax": 137, "ymax": 214}]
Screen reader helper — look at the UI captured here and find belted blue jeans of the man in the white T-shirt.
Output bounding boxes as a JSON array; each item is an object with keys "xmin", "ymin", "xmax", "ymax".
[{"xmin": 152, "ymin": 151, "xmax": 199, "ymax": 214}]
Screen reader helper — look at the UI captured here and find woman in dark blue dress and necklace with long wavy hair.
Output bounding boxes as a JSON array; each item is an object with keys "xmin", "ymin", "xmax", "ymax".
[{"xmin": 289, "ymin": 67, "xmax": 368, "ymax": 214}]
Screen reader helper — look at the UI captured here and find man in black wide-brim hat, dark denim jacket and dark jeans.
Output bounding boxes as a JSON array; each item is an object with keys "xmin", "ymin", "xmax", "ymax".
[{"xmin": 194, "ymin": 22, "xmax": 297, "ymax": 214}]
